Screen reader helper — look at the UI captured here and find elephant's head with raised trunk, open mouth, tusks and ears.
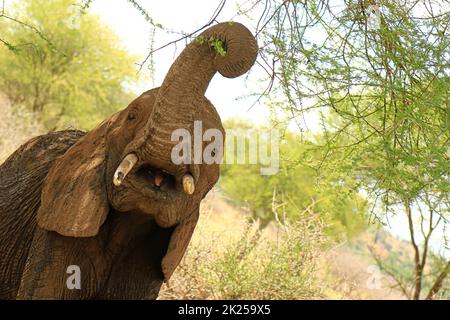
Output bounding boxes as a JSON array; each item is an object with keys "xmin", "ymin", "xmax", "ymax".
[{"xmin": 37, "ymin": 22, "xmax": 257, "ymax": 278}]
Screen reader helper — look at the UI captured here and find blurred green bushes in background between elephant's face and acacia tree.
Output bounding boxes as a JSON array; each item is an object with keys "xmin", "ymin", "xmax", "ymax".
[{"xmin": 219, "ymin": 121, "xmax": 367, "ymax": 237}]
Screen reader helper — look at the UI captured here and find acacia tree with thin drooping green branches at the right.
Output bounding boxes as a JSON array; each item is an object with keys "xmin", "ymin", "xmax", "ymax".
[{"xmin": 248, "ymin": 0, "xmax": 450, "ymax": 299}]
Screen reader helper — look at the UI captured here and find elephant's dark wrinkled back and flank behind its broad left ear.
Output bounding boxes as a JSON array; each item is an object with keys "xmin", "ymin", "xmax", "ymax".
[{"xmin": 0, "ymin": 130, "xmax": 85, "ymax": 299}]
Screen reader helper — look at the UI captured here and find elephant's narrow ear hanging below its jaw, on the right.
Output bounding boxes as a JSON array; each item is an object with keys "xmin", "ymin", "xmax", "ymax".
[{"xmin": 161, "ymin": 208, "xmax": 199, "ymax": 282}]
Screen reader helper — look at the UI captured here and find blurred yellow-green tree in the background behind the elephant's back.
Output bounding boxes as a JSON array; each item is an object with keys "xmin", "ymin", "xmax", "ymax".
[{"xmin": 0, "ymin": 0, "xmax": 142, "ymax": 129}]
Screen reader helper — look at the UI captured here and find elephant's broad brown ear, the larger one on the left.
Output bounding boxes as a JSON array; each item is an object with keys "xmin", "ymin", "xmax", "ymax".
[{"xmin": 37, "ymin": 117, "xmax": 115, "ymax": 237}]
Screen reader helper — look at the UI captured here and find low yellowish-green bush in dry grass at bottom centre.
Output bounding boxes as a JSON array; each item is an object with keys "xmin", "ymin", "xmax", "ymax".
[{"xmin": 205, "ymin": 220, "xmax": 325, "ymax": 299}]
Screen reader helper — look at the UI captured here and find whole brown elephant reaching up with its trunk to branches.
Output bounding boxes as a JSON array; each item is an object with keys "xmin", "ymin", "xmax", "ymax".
[{"xmin": 0, "ymin": 22, "xmax": 258, "ymax": 300}]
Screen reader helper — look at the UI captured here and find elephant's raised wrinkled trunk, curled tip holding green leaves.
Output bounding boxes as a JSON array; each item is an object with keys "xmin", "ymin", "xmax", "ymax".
[{"xmin": 121, "ymin": 22, "xmax": 258, "ymax": 178}]
